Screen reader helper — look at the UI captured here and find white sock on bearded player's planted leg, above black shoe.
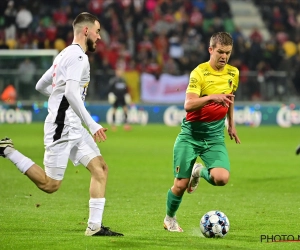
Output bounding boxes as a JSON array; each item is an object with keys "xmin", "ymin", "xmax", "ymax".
[{"xmin": 88, "ymin": 198, "xmax": 105, "ymax": 230}]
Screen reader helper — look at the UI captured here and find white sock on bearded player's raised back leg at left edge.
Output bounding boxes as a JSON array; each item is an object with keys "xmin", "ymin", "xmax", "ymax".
[{"xmin": 4, "ymin": 147, "xmax": 34, "ymax": 174}]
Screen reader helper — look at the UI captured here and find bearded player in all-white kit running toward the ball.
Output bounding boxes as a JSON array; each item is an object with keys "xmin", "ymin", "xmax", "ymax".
[{"xmin": 0, "ymin": 12, "xmax": 123, "ymax": 236}]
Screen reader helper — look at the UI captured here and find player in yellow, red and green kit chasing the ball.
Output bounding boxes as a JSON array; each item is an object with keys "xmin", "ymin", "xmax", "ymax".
[{"xmin": 164, "ymin": 32, "xmax": 240, "ymax": 232}]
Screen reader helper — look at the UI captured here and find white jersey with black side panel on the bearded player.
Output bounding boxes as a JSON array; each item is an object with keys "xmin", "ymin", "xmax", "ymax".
[{"xmin": 45, "ymin": 44, "xmax": 90, "ymax": 127}]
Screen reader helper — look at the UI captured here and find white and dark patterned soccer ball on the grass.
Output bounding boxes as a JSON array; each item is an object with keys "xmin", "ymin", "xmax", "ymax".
[{"xmin": 200, "ymin": 210, "xmax": 229, "ymax": 238}]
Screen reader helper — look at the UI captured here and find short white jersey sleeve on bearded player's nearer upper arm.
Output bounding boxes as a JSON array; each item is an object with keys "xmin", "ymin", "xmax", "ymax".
[{"xmin": 66, "ymin": 54, "xmax": 88, "ymax": 82}]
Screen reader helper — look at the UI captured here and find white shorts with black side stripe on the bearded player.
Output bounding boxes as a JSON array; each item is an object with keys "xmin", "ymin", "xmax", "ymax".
[{"xmin": 44, "ymin": 123, "xmax": 101, "ymax": 180}]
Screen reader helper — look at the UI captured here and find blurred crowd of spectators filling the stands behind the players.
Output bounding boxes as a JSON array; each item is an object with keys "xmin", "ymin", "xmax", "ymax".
[{"xmin": 0, "ymin": 0, "xmax": 300, "ymax": 100}]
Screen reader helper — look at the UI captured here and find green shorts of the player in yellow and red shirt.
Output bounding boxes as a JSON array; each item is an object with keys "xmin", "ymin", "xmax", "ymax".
[{"xmin": 173, "ymin": 134, "xmax": 230, "ymax": 178}]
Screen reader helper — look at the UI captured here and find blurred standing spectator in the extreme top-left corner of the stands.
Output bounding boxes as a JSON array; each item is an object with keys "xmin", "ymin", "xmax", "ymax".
[{"xmin": 4, "ymin": 1, "xmax": 17, "ymax": 40}]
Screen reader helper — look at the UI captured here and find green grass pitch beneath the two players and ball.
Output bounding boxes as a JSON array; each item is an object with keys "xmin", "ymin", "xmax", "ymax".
[{"xmin": 0, "ymin": 124, "xmax": 300, "ymax": 250}]
